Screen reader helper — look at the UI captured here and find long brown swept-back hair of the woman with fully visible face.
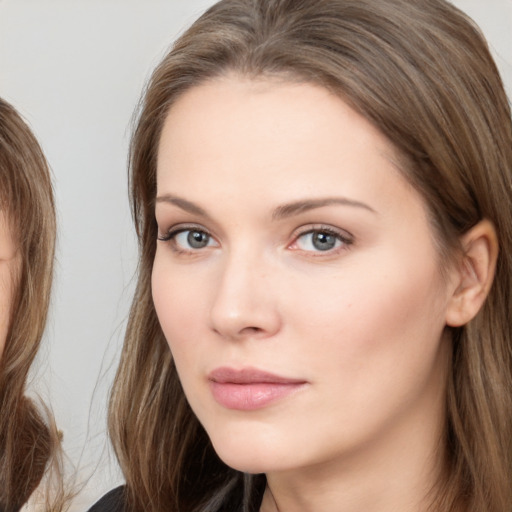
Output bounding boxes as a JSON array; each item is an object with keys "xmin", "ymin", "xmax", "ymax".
[{"xmin": 109, "ymin": 0, "xmax": 512, "ymax": 512}]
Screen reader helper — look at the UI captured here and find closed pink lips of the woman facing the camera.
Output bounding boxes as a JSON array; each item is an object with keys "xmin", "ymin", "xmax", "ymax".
[{"xmin": 208, "ymin": 367, "xmax": 306, "ymax": 411}]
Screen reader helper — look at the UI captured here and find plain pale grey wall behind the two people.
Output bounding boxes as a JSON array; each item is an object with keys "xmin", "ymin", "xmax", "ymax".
[{"xmin": 0, "ymin": 0, "xmax": 512, "ymax": 510}]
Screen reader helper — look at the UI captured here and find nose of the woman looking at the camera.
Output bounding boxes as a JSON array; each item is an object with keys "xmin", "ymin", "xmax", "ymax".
[{"xmin": 210, "ymin": 253, "xmax": 281, "ymax": 340}]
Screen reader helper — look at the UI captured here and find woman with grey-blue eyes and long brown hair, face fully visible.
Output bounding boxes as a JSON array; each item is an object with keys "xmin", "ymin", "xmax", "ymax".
[{"xmin": 93, "ymin": 0, "xmax": 512, "ymax": 512}]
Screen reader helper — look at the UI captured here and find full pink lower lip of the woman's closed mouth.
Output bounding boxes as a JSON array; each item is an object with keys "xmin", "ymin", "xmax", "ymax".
[{"xmin": 210, "ymin": 381, "xmax": 304, "ymax": 411}]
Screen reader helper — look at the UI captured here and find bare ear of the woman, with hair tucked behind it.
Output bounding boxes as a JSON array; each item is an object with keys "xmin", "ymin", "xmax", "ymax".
[{"xmin": 446, "ymin": 219, "xmax": 498, "ymax": 327}]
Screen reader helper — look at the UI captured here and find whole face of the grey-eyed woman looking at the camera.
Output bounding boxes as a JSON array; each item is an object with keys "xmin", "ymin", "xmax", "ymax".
[{"xmin": 152, "ymin": 76, "xmax": 456, "ymax": 474}]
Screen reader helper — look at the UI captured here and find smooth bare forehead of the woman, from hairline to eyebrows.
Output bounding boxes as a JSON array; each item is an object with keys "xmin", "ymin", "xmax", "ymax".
[{"xmin": 157, "ymin": 76, "xmax": 420, "ymax": 215}]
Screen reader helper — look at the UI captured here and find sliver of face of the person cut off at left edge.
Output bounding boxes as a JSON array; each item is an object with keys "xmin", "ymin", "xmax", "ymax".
[{"xmin": 0, "ymin": 211, "xmax": 19, "ymax": 356}]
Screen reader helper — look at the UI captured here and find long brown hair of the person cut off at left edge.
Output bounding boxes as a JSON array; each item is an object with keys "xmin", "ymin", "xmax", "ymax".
[{"xmin": 0, "ymin": 99, "xmax": 63, "ymax": 512}]
